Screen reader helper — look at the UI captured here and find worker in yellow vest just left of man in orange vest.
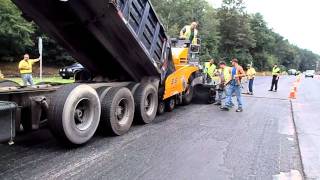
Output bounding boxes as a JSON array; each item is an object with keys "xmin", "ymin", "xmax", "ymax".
[{"xmin": 215, "ymin": 61, "xmax": 231, "ymax": 106}]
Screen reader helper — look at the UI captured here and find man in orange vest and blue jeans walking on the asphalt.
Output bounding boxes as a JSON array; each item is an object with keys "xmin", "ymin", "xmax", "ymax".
[{"xmin": 221, "ymin": 59, "xmax": 246, "ymax": 112}]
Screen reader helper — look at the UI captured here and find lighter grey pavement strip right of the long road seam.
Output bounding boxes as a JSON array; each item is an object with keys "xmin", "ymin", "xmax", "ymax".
[{"xmin": 293, "ymin": 76, "xmax": 320, "ymax": 179}]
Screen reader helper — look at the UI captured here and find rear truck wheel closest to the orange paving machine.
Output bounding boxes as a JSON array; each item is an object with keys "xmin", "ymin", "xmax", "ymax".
[{"xmin": 134, "ymin": 84, "xmax": 158, "ymax": 124}]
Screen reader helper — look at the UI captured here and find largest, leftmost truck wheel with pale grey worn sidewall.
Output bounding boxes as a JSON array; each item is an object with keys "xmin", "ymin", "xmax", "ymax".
[{"xmin": 48, "ymin": 84, "xmax": 101, "ymax": 145}]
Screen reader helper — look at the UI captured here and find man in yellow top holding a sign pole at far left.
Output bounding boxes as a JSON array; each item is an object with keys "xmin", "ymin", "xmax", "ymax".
[{"xmin": 19, "ymin": 54, "xmax": 40, "ymax": 86}]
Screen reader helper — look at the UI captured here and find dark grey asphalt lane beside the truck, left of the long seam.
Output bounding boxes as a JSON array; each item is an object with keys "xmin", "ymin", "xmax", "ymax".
[{"xmin": 0, "ymin": 77, "xmax": 306, "ymax": 180}]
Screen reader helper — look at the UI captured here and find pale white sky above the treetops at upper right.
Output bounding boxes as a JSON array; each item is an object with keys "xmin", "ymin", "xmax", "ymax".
[{"xmin": 207, "ymin": 0, "xmax": 320, "ymax": 54}]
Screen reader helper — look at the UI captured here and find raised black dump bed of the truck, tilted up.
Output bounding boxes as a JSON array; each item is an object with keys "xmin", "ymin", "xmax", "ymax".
[{"xmin": 13, "ymin": 0, "xmax": 170, "ymax": 81}]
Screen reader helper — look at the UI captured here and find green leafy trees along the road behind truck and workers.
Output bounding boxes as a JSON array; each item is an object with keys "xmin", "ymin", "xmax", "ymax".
[{"xmin": 0, "ymin": 0, "xmax": 320, "ymax": 71}]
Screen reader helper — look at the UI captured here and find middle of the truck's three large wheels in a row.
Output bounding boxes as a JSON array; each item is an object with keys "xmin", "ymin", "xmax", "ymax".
[{"xmin": 100, "ymin": 87, "xmax": 134, "ymax": 136}]
